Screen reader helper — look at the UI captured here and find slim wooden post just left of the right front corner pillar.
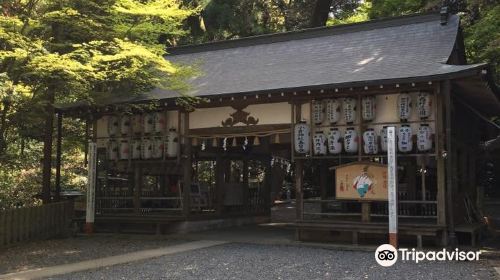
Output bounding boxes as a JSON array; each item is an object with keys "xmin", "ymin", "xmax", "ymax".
[{"xmin": 435, "ymin": 86, "xmax": 446, "ymax": 226}]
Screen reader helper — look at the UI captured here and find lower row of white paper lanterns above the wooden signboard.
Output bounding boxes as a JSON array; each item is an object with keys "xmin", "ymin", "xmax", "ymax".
[{"xmin": 294, "ymin": 122, "xmax": 433, "ymax": 155}]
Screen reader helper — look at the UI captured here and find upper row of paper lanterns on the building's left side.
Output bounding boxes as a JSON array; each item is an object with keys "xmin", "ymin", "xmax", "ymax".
[{"xmin": 107, "ymin": 112, "xmax": 167, "ymax": 136}]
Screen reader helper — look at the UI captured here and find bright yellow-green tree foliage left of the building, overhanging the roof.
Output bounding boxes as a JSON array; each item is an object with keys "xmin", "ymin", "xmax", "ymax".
[{"xmin": 0, "ymin": 0, "xmax": 197, "ymax": 207}]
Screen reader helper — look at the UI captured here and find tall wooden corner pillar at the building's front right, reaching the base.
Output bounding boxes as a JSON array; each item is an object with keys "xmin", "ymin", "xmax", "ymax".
[{"xmin": 441, "ymin": 80, "xmax": 456, "ymax": 245}]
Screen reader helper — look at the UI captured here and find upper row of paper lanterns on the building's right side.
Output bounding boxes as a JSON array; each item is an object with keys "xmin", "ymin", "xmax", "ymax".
[{"xmin": 312, "ymin": 92, "xmax": 432, "ymax": 125}]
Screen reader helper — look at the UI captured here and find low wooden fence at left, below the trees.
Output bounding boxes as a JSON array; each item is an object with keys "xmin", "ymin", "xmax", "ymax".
[{"xmin": 0, "ymin": 201, "xmax": 73, "ymax": 247}]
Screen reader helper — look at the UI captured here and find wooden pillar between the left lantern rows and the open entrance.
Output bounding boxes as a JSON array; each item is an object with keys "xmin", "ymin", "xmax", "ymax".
[{"xmin": 182, "ymin": 112, "xmax": 193, "ymax": 217}]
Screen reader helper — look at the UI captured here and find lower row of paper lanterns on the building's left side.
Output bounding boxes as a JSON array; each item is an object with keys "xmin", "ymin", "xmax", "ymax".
[{"xmin": 107, "ymin": 129, "xmax": 179, "ymax": 160}]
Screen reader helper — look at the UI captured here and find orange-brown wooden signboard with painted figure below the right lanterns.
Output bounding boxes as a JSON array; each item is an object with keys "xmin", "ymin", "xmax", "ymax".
[{"xmin": 335, "ymin": 162, "xmax": 387, "ymax": 201}]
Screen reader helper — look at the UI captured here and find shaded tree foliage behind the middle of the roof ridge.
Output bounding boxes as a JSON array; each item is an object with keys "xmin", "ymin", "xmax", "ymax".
[{"xmin": 182, "ymin": 0, "xmax": 361, "ymax": 43}]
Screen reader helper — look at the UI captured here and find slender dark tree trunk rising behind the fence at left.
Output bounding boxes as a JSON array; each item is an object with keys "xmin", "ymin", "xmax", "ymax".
[{"xmin": 42, "ymin": 88, "xmax": 55, "ymax": 204}]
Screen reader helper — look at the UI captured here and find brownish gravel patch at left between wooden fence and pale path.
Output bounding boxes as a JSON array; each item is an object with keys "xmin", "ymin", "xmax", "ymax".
[{"xmin": 0, "ymin": 235, "xmax": 181, "ymax": 274}]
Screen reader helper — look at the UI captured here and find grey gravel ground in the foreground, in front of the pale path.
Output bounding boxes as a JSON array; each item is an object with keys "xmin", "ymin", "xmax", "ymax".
[{"xmin": 50, "ymin": 243, "xmax": 496, "ymax": 280}]
